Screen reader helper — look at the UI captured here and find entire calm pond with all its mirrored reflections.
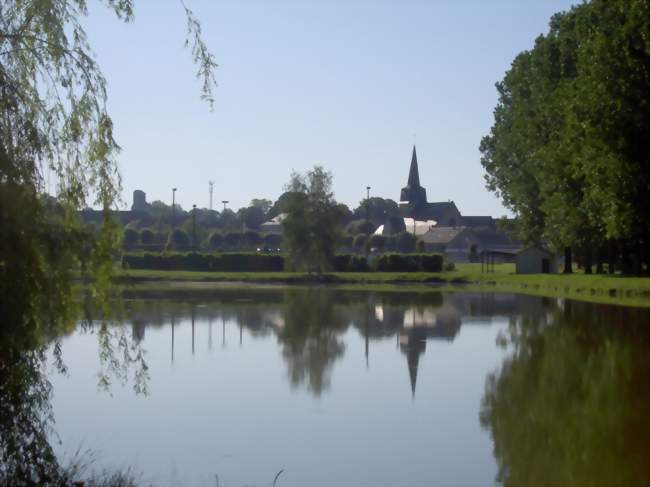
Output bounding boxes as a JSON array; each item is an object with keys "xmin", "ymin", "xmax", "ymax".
[{"xmin": 43, "ymin": 288, "xmax": 650, "ymax": 487}]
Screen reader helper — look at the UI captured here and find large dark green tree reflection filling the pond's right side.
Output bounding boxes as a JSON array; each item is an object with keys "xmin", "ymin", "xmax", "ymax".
[{"xmin": 481, "ymin": 301, "xmax": 650, "ymax": 486}]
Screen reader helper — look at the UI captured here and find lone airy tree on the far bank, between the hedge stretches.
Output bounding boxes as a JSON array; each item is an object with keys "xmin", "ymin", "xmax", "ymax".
[{"xmin": 282, "ymin": 166, "xmax": 341, "ymax": 274}]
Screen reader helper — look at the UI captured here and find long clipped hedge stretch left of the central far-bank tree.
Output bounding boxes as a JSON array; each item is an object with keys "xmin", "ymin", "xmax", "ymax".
[{"xmin": 122, "ymin": 252, "xmax": 284, "ymax": 272}]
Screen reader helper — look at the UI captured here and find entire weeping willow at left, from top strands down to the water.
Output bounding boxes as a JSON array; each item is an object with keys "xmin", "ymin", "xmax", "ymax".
[{"xmin": 0, "ymin": 0, "xmax": 216, "ymax": 485}]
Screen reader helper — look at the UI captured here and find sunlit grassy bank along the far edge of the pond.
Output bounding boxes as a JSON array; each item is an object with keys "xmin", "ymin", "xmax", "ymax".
[{"xmin": 112, "ymin": 264, "xmax": 650, "ymax": 306}]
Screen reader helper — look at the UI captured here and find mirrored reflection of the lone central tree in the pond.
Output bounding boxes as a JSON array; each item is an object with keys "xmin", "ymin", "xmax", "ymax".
[{"xmin": 278, "ymin": 288, "xmax": 347, "ymax": 395}]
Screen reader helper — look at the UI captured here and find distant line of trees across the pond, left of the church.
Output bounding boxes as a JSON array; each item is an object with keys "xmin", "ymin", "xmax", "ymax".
[{"xmin": 114, "ymin": 170, "xmax": 423, "ymax": 260}]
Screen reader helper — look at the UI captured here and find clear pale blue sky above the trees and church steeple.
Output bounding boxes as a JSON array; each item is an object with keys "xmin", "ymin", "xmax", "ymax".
[{"xmin": 84, "ymin": 0, "xmax": 575, "ymax": 216}]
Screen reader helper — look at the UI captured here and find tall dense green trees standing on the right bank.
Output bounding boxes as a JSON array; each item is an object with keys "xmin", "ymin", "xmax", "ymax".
[{"xmin": 480, "ymin": 0, "xmax": 650, "ymax": 273}]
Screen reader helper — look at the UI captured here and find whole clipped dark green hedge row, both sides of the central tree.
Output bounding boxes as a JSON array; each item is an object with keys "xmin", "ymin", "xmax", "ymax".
[{"xmin": 122, "ymin": 252, "xmax": 442, "ymax": 272}]
